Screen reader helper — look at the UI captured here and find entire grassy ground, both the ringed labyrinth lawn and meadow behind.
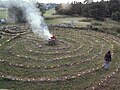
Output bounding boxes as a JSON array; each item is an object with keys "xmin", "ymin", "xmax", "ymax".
[{"xmin": 0, "ymin": 10, "xmax": 120, "ymax": 90}]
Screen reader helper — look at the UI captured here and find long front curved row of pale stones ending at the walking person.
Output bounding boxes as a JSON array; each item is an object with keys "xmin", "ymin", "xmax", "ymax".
[{"xmin": 1, "ymin": 65, "xmax": 103, "ymax": 82}]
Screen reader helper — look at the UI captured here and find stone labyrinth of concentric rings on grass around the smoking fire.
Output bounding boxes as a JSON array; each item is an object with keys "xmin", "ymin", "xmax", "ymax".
[{"xmin": 0, "ymin": 25, "xmax": 120, "ymax": 88}]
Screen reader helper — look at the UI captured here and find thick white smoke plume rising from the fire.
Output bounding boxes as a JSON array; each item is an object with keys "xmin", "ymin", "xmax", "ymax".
[{"xmin": 2, "ymin": 0, "xmax": 52, "ymax": 40}]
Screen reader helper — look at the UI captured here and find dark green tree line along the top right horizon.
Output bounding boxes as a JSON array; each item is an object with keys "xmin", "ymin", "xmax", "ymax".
[{"xmin": 55, "ymin": 0, "xmax": 120, "ymax": 21}]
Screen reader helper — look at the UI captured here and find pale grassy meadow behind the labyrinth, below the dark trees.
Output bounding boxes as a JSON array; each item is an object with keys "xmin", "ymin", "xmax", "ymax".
[{"xmin": 44, "ymin": 9, "xmax": 120, "ymax": 37}]
